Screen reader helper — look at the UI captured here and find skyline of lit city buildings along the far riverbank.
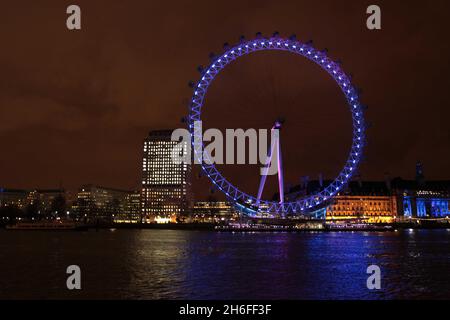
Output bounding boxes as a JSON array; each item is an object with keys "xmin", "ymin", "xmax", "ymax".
[{"xmin": 0, "ymin": 165, "xmax": 450, "ymax": 222}]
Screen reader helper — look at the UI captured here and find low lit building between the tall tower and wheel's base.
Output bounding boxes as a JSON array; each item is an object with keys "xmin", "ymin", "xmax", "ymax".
[{"xmin": 192, "ymin": 201, "xmax": 239, "ymax": 222}]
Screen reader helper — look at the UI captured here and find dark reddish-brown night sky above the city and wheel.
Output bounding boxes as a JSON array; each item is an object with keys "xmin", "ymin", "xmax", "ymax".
[{"xmin": 0, "ymin": 0, "xmax": 450, "ymax": 198}]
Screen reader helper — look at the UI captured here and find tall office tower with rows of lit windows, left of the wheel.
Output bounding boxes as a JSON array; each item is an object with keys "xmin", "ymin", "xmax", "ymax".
[{"xmin": 141, "ymin": 130, "xmax": 191, "ymax": 222}]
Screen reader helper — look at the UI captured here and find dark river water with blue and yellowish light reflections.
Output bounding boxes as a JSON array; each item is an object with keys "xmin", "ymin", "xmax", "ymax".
[{"xmin": 0, "ymin": 230, "xmax": 450, "ymax": 299}]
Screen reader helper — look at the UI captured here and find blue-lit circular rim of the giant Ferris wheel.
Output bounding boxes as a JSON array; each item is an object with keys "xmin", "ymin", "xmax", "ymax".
[{"xmin": 188, "ymin": 37, "xmax": 364, "ymax": 214}]
